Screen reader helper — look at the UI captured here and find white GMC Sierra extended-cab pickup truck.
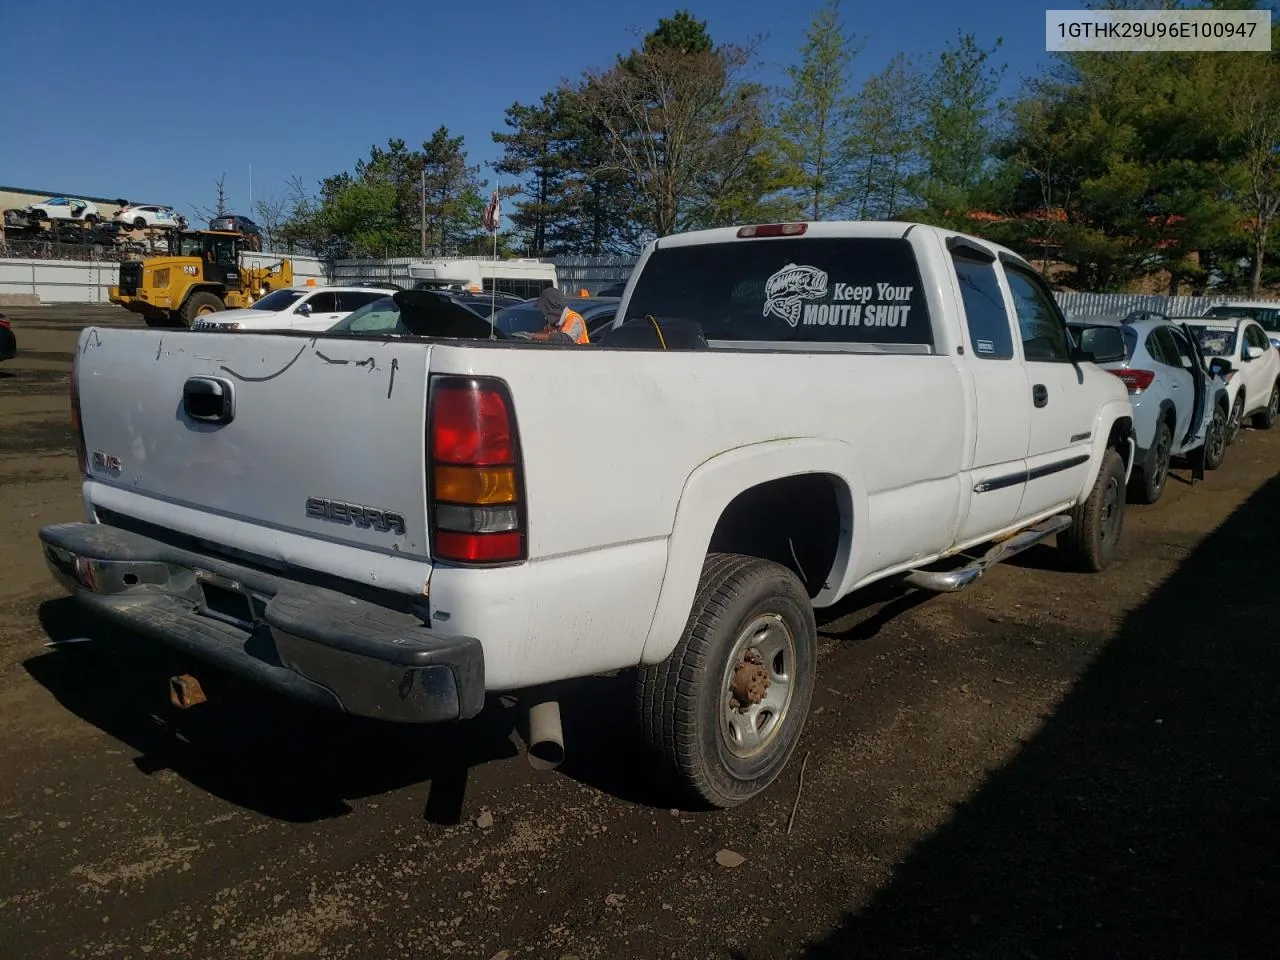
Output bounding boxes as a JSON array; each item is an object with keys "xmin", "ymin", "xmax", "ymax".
[{"xmin": 40, "ymin": 223, "xmax": 1133, "ymax": 806}]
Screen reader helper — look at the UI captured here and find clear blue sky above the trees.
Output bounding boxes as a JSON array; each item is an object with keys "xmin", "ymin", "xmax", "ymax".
[{"xmin": 0, "ymin": 0, "xmax": 1068, "ymax": 220}]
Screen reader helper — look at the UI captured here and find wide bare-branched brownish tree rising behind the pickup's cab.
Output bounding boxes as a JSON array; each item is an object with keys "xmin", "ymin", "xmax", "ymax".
[{"xmin": 576, "ymin": 35, "xmax": 762, "ymax": 237}]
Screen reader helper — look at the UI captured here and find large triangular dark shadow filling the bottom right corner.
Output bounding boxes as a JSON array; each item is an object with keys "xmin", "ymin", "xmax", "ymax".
[{"xmin": 805, "ymin": 477, "xmax": 1280, "ymax": 960}]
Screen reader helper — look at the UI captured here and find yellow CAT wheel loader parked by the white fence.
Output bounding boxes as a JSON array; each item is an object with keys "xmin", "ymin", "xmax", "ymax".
[{"xmin": 110, "ymin": 230, "xmax": 293, "ymax": 326}]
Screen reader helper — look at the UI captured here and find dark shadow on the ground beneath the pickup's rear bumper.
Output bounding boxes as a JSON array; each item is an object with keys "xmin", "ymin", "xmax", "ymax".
[{"xmin": 23, "ymin": 598, "xmax": 671, "ymax": 824}]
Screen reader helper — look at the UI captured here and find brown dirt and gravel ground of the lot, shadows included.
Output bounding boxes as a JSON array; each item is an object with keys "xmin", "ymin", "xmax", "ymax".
[{"xmin": 0, "ymin": 307, "xmax": 1280, "ymax": 960}]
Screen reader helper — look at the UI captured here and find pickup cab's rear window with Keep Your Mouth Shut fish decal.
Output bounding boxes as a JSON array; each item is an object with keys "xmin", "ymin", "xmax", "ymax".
[{"xmin": 626, "ymin": 237, "xmax": 933, "ymax": 346}]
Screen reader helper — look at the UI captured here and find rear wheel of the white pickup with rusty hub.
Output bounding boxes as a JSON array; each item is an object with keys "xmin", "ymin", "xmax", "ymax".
[{"xmin": 636, "ymin": 553, "xmax": 818, "ymax": 809}]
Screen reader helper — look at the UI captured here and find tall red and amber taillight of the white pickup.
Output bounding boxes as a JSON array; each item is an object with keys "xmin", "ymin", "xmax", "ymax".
[{"xmin": 428, "ymin": 378, "xmax": 526, "ymax": 563}]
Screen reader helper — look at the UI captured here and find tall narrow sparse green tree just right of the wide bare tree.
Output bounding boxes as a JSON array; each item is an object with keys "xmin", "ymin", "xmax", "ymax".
[{"xmin": 777, "ymin": 0, "xmax": 861, "ymax": 220}]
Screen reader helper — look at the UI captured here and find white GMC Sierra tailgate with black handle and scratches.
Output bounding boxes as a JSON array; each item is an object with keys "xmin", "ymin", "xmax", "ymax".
[{"xmin": 76, "ymin": 328, "xmax": 430, "ymax": 558}]
